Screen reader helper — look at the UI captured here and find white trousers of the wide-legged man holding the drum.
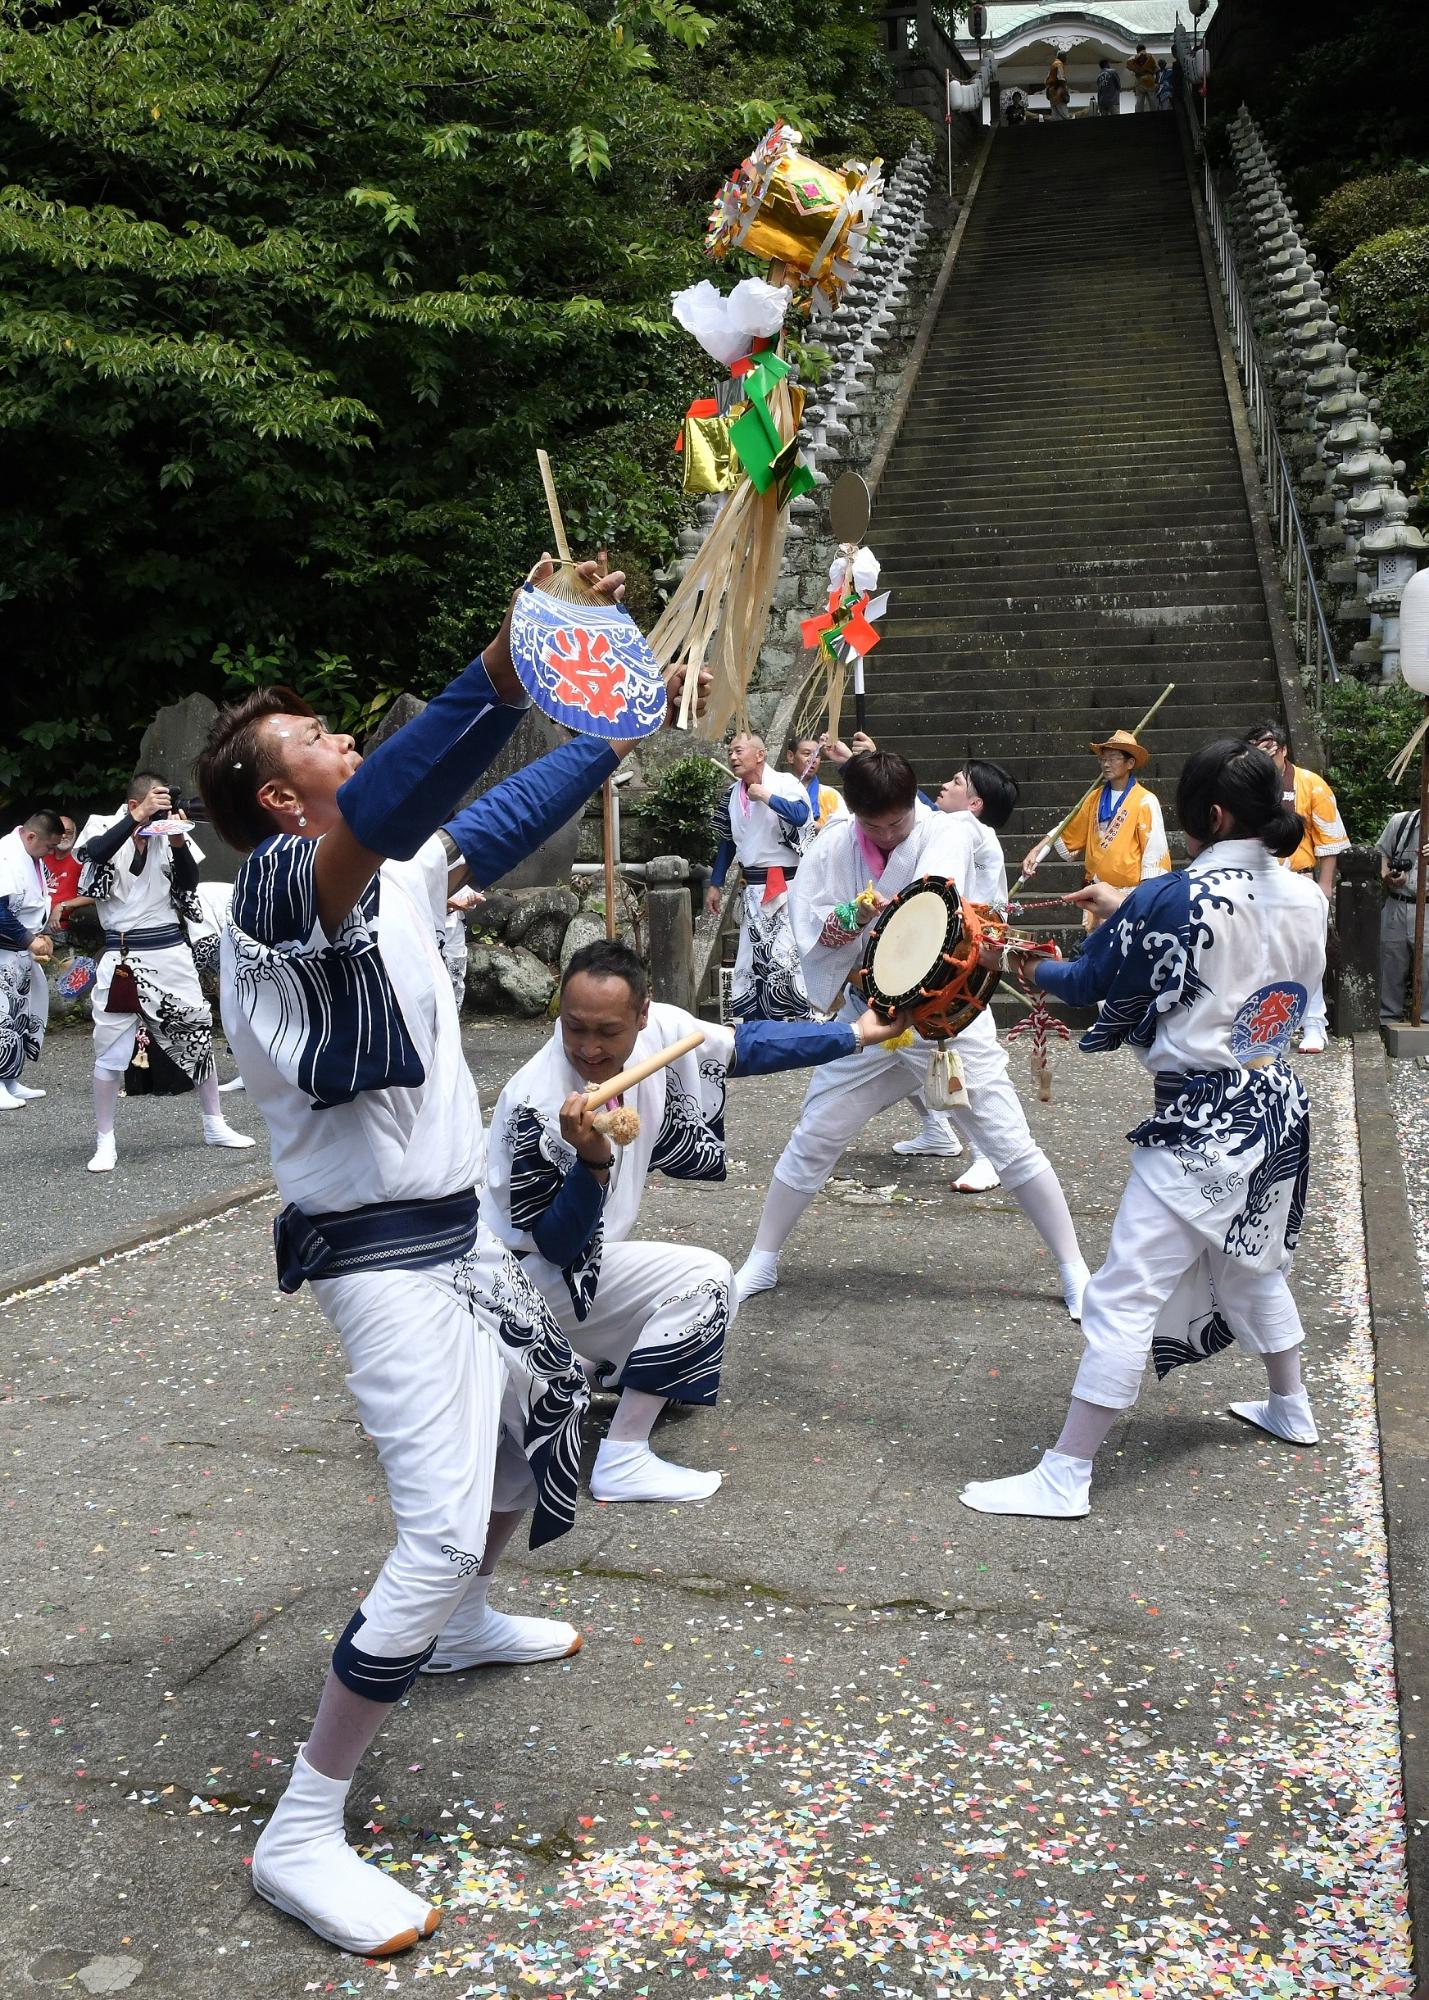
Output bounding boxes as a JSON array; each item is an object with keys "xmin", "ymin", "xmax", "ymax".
[{"xmin": 775, "ymin": 1010, "xmax": 1049, "ymax": 1194}]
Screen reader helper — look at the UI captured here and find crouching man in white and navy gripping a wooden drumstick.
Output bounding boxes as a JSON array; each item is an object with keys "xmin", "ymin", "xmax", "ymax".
[{"xmin": 476, "ymin": 938, "xmax": 901, "ymax": 1504}]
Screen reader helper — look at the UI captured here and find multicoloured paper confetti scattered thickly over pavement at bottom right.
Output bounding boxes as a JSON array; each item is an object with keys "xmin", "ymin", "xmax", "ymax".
[{"xmin": 242, "ymin": 1062, "xmax": 1411, "ymax": 2000}]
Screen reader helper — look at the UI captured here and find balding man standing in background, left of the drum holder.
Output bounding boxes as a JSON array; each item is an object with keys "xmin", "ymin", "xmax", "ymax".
[{"xmin": 704, "ymin": 732, "xmax": 813, "ymax": 1020}]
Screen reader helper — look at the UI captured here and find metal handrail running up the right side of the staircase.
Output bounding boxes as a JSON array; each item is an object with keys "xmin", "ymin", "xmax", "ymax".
[{"xmin": 1173, "ymin": 22, "xmax": 1339, "ymax": 718}]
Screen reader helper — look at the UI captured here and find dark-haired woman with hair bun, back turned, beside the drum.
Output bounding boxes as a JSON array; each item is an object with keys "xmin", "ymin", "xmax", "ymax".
[{"xmin": 961, "ymin": 740, "xmax": 1329, "ymax": 1518}]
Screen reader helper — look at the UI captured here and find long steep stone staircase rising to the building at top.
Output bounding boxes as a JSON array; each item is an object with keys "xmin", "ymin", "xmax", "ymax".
[{"xmin": 869, "ymin": 114, "xmax": 1281, "ymax": 930}]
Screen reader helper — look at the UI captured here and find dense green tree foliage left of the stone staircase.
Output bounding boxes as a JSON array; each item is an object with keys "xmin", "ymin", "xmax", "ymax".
[{"xmin": 0, "ymin": 0, "xmax": 907, "ymax": 794}]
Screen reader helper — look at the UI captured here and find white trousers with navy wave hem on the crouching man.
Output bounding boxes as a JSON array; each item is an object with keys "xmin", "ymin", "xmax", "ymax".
[{"xmin": 526, "ymin": 1242, "xmax": 737, "ymax": 1404}]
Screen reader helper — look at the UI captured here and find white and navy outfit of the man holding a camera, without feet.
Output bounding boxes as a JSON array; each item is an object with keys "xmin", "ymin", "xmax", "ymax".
[{"xmin": 74, "ymin": 806, "xmax": 212, "ymax": 1082}]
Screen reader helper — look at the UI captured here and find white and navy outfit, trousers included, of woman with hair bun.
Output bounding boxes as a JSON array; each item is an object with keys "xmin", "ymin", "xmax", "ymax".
[{"xmin": 1037, "ymin": 840, "xmax": 1329, "ymax": 1408}]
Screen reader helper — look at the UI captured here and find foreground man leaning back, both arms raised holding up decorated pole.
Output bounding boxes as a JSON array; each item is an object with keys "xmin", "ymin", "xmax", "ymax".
[{"xmin": 198, "ymin": 558, "xmax": 708, "ymax": 1956}]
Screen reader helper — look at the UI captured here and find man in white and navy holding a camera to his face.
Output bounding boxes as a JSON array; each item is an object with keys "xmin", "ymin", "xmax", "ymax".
[{"xmin": 74, "ymin": 770, "xmax": 252, "ymax": 1174}]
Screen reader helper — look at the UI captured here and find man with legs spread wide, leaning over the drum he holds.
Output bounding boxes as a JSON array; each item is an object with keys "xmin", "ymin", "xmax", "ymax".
[{"xmin": 735, "ymin": 750, "xmax": 1087, "ymax": 1318}]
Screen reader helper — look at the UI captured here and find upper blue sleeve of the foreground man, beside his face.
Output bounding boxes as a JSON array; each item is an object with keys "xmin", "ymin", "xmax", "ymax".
[{"xmin": 338, "ymin": 656, "xmax": 526, "ymax": 860}]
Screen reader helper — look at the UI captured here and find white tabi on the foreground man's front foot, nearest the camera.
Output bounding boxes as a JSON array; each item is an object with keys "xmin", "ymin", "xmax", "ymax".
[{"xmin": 252, "ymin": 1750, "xmax": 440, "ymax": 1958}]
